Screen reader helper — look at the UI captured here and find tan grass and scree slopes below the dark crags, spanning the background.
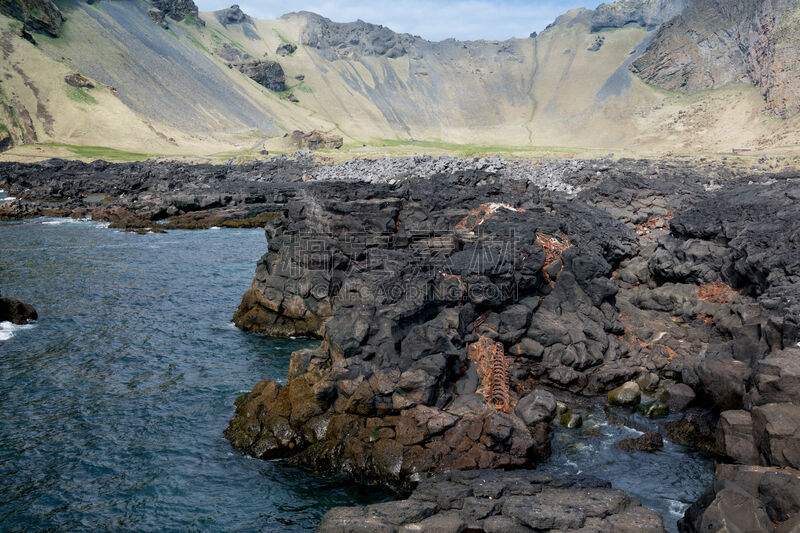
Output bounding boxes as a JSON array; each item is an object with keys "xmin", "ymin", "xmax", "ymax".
[{"xmin": 0, "ymin": 0, "xmax": 800, "ymax": 160}]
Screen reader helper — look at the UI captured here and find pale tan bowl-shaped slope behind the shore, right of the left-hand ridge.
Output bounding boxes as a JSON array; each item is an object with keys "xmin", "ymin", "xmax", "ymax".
[{"xmin": 198, "ymin": 10, "xmax": 800, "ymax": 154}]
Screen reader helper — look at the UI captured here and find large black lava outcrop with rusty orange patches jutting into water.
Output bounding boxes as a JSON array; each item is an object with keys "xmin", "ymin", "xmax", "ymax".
[{"xmin": 226, "ymin": 156, "xmax": 800, "ymax": 516}]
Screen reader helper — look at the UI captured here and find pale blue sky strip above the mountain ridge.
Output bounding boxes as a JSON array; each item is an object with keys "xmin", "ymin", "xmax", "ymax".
[{"xmin": 195, "ymin": 0, "xmax": 611, "ymax": 41}]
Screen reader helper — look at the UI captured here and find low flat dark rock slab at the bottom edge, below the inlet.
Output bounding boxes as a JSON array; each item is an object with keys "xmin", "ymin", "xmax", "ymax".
[{"xmin": 317, "ymin": 470, "xmax": 664, "ymax": 533}]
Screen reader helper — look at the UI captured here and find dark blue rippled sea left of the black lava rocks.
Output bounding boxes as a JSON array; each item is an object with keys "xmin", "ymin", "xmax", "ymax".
[{"xmin": 0, "ymin": 219, "xmax": 385, "ymax": 531}]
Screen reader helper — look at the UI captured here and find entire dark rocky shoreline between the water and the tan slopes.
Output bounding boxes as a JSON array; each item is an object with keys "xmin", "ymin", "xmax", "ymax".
[{"xmin": 0, "ymin": 155, "xmax": 800, "ymax": 531}]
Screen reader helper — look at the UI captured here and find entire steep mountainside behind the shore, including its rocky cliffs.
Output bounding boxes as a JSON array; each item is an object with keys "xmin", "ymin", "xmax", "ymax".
[{"xmin": 0, "ymin": 0, "xmax": 800, "ymax": 159}]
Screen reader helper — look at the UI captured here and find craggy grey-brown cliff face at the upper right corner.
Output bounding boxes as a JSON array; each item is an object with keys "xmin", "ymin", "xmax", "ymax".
[{"xmin": 631, "ymin": 0, "xmax": 800, "ymax": 118}]
